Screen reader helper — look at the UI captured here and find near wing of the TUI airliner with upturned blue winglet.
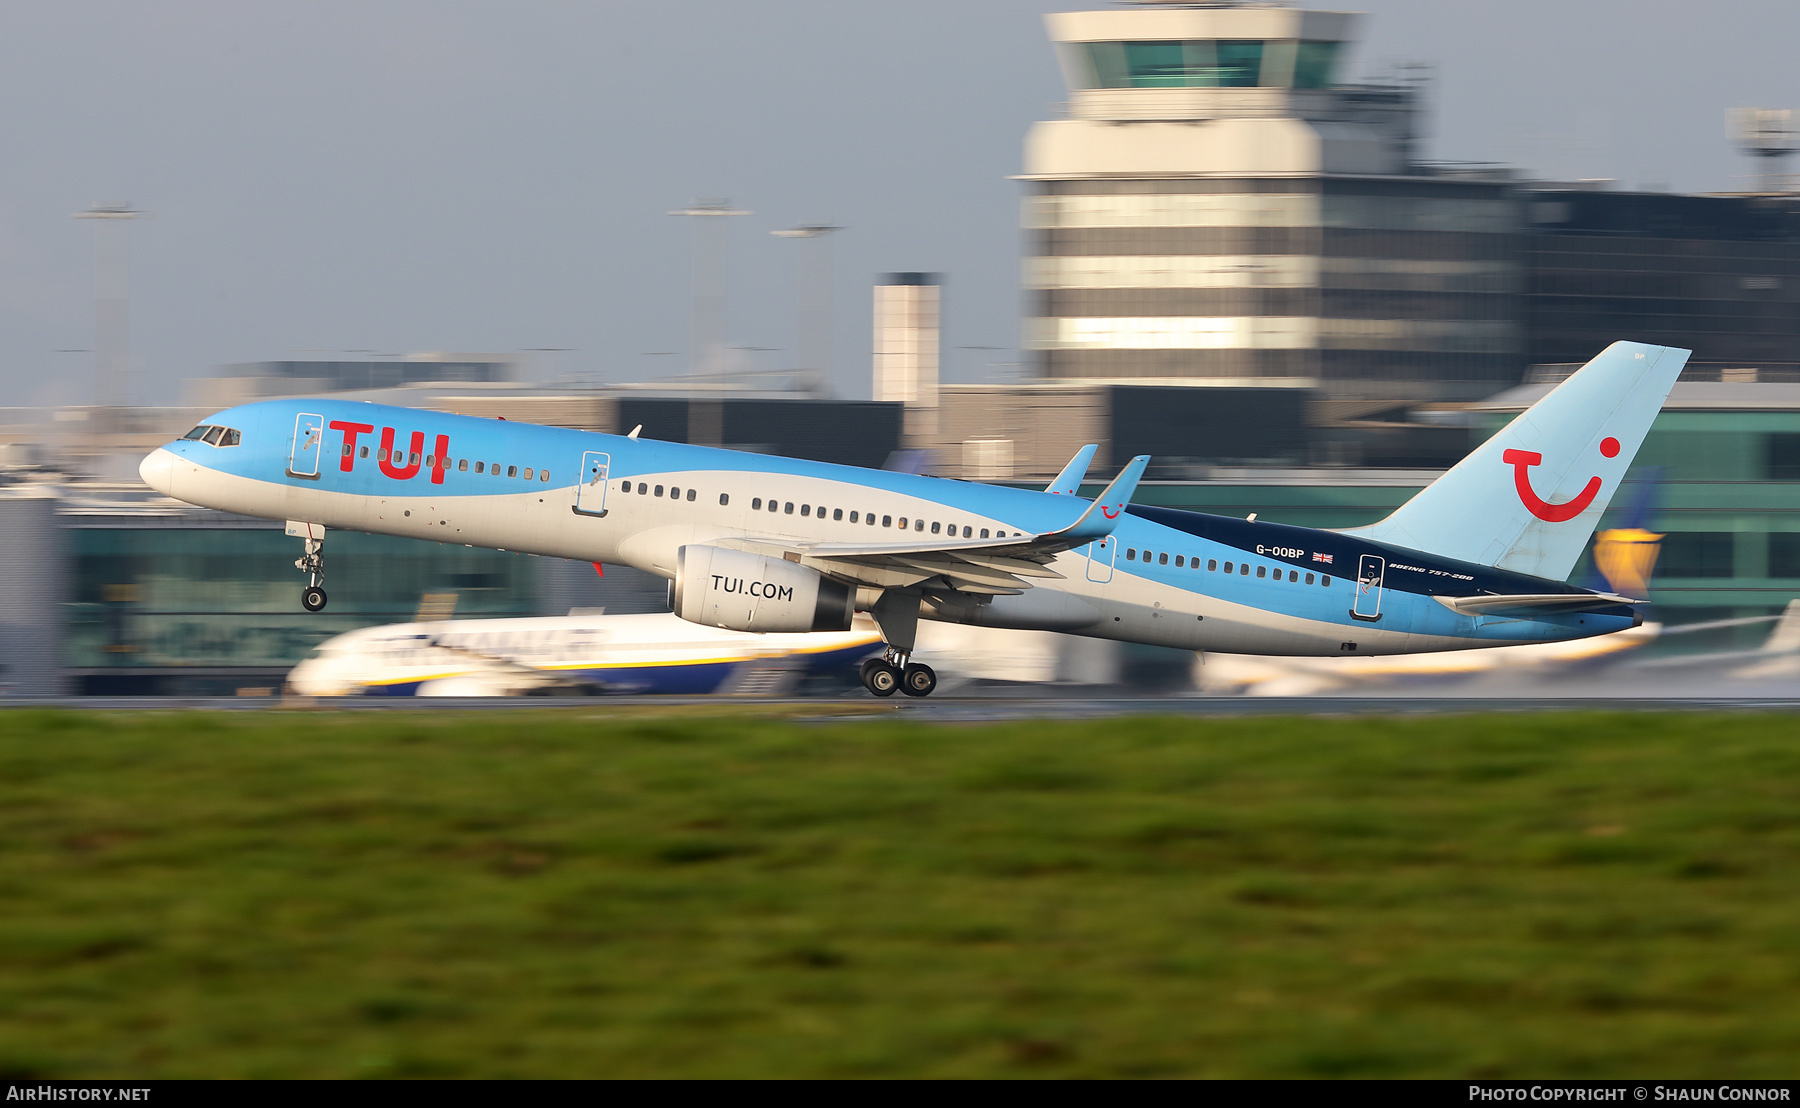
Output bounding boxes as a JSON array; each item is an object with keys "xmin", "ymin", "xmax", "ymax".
[{"xmin": 733, "ymin": 455, "xmax": 1150, "ymax": 595}]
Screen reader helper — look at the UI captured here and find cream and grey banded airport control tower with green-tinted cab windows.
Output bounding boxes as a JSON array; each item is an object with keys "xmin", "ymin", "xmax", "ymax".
[{"xmin": 1024, "ymin": 0, "xmax": 1525, "ymax": 401}]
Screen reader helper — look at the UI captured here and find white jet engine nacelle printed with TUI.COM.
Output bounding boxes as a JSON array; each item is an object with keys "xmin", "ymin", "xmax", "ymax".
[{"xmin": 673, "ymin": 547, "xmax": 855, "ymax": 633}]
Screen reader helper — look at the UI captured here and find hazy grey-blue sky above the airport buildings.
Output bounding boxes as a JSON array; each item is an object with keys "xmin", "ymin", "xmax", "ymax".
[{"xmin": 0, "ymin": 0, "xmax": 1800, "ymax": 407}]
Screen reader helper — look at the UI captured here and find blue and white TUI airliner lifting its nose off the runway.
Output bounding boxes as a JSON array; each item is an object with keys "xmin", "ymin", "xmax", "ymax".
[{"xmin": 140, "ymin": 342, "xmax": 1688, "ymax": 696}]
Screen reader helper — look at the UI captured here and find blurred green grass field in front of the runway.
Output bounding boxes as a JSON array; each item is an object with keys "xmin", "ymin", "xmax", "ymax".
[{"xmin": 0, "ymin": 705, "xmax": 1800, "ymax": 1077}]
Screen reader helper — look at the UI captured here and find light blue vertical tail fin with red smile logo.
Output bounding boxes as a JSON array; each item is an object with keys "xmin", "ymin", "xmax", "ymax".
[{"xmin": 1350, "ymin": 342, "xmax": 1688, "ymax": 581}]
